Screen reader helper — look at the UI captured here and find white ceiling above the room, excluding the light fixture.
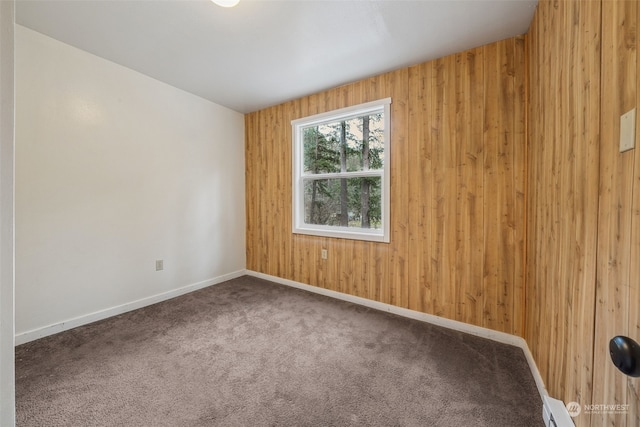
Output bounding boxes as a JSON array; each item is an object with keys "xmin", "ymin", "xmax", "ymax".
[{"xmin": 16, "ymin": 0, "xmax": 537, "ymax": 113}]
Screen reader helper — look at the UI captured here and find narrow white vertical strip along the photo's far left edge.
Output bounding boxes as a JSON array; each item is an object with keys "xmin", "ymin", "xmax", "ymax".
[{"xmin": 0, "ymin": 0, "xmax": 15, "ymax": 427}]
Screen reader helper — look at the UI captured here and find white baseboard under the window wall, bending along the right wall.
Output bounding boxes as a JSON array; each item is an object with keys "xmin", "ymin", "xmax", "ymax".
[{"xmin": 246, "ymin": 270, "xmax": 548, "ymax": 400}]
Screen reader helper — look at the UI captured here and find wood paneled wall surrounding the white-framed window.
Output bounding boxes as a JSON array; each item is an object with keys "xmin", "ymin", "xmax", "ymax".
[{"xmin": 245, "ymin": 37, "xmax": 527, "ymax": 335}]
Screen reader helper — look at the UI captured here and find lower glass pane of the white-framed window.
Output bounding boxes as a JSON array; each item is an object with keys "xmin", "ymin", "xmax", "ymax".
[{"xmin": 304, "ymin": 177, "xmax": 382, "ymax": 229}]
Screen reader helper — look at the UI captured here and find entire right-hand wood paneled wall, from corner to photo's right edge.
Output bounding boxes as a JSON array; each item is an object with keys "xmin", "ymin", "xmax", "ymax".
[{"xmin": 525, "ymin": 0, "xmax": 640, "ymax": 427}]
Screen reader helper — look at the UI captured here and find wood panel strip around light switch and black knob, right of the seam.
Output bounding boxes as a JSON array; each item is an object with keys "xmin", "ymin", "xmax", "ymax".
[{"xmin": 591, "ymin": 0, "xmax": 640, "ymax": 427}]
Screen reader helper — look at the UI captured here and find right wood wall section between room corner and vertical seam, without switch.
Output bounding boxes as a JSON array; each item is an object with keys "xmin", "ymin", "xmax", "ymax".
[{"xmin": 525, "ymin": 1, "xmax": 600, "ymax": 425}]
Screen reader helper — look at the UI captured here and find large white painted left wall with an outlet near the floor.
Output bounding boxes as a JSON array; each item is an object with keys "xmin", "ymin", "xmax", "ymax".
[{"xmin": 15, "ymin": 26, "xmax": 245, "ymax": 343}]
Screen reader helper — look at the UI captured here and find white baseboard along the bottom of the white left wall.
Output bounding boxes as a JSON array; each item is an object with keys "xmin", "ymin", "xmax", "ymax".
[{"xmin": 15, "ymin": 269, "xmax": 246, "ymax": 345}]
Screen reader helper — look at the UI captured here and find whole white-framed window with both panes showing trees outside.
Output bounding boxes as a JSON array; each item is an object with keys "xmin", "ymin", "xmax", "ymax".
[{"xmin": 291, "ymin": 98, "xmax": 391, "ymax": 242}]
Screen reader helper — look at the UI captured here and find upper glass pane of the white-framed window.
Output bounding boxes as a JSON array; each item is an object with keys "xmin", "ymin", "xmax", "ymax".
[{"xmin": 303, "ymin": 112, "xmax": 384, "ymax": 174}]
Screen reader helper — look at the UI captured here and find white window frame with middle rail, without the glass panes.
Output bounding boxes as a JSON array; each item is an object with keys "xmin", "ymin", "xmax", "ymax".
[{"xmin": 291, "ymin": 98, "xmax": 391, "ymax": 243}]
